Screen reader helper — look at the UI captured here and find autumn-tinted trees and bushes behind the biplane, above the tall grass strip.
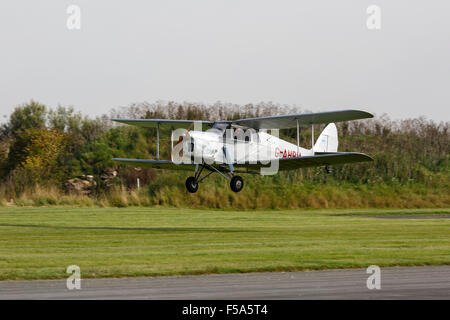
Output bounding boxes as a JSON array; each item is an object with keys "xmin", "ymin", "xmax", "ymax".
[{"xmin": 0, "ymin": 101, "xmax": 450, "ymax": 209}]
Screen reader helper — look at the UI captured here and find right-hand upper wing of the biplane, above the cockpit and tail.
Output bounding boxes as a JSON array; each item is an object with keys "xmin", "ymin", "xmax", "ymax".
[{"xmin": 233, "ymin": 110, "xmax": 373, "ymax": 129}]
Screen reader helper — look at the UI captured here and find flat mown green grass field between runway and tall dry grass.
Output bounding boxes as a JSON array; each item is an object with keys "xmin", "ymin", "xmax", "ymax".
[{"xmin": 0, "ymin": 207, "xmax": 450, "ymax": 280}]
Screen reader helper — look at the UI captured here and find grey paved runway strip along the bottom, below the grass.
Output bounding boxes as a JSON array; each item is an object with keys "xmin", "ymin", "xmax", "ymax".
[{"xmin": 0, "ymin": 266, "xmax": 450, "ymax": 300}]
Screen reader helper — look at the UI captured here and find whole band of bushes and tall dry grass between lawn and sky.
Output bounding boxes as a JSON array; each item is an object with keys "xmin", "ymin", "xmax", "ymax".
[{"xmin": 0, "ymin": 101, "xmax": 450, "ymax": 209}]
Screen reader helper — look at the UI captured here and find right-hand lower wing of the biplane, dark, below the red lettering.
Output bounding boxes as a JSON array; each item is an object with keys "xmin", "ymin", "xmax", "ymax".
[{"xmin": 234, "ymin": 152, "xmax": 373, "ymax": 171}]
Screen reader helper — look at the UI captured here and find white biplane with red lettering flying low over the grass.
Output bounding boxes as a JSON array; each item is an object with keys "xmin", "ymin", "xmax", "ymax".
[{"xmin": 113, "ymin": 110, "xmax": 373, "ymax": 193}]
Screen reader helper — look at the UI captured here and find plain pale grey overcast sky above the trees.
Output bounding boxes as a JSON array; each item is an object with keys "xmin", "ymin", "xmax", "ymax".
[{"xmin": 0, "ymin": 0, "xmax": 450, "ymax": 121}]
